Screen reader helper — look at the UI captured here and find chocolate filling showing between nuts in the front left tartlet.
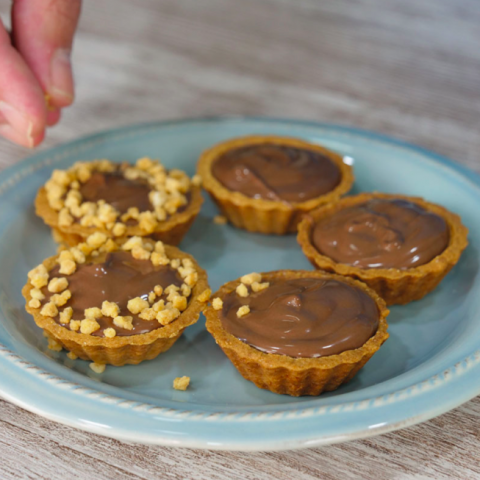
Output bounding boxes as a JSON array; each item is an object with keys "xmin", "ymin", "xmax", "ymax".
[{"xmin": 42, "ymin": 251, "xmax": 183, "ymax": 337}]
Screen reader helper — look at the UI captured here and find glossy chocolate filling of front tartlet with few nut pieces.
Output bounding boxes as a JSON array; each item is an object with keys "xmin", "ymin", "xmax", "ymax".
[{"xmin": 220, "ymin": 278, "xmax": 379, "ymax": 358}]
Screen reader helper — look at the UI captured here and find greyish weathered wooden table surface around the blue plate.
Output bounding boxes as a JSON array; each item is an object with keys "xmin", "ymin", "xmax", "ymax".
[{"xmin": 0, "ymin": 0, "xmax": 480, "ymax": 480}]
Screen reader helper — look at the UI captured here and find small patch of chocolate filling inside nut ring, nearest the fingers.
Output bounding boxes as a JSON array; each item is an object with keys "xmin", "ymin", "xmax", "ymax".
[{"xmin": 80, "ymin": 172, "xmax": 152, "ymax": 214}]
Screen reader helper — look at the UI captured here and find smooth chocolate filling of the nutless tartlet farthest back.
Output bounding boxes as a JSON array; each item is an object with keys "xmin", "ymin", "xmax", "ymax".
[{"xmin": 212, "ymin": 144, "xmax": 341, "ymax": 202}]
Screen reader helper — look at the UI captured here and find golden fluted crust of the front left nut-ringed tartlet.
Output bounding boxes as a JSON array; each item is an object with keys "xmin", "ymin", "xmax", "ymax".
[{"xmin": 22, "ymin": 245, "xmax": 209, "ymax": 366}]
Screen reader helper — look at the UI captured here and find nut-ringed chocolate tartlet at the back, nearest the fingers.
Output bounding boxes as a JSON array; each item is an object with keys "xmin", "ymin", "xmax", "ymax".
[{"xmin": 35, "ymin": 158, "xmax": 203, "ymax": 246}]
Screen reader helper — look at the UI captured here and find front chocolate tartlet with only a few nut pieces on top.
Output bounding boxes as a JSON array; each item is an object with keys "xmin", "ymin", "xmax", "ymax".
[{"xmin": 204, "ymin": 270, "xmax": 389, "ymax": 396}]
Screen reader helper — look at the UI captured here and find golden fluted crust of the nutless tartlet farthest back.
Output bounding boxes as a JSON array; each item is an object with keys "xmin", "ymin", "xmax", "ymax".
[{"xmin": 197, "ymin": 135, "xmax": 354, "ymax": 235}]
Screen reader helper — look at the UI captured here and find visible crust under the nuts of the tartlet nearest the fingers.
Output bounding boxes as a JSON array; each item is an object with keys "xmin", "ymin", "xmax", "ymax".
[{"xmin": 35, "ymin": 185, "xmax": 203, "ymax": 247}]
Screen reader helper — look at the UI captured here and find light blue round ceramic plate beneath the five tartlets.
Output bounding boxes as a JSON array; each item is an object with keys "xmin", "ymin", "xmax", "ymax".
[{"xmin": 0, "ymin": 118, "xmax": 480, "ymax": 450}]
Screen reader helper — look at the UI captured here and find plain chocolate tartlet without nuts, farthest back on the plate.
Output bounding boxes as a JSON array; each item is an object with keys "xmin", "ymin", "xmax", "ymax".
[{"xmin": 198, "ymin": 136, "xmax": 353, "ymax": 235}]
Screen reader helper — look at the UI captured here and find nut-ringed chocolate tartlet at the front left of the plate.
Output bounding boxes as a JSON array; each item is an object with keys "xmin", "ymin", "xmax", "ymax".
[{"xmin": 22, "ymin": 232, "xmax": 210, "ymax": 366}]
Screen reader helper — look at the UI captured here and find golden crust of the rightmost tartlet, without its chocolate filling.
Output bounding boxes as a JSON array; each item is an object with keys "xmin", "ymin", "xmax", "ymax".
[{"xmin": 297, "ymin": 192, "xmax": 468, "ymax": 305}]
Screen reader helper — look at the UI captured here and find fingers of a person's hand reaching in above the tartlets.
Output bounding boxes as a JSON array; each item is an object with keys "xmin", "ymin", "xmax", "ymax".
[{"xmin": 0, "ymin": 0, "xmax": 81, "ymax": 148}]
